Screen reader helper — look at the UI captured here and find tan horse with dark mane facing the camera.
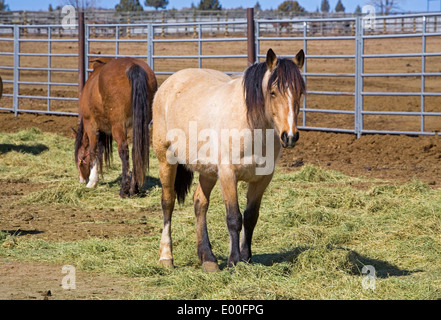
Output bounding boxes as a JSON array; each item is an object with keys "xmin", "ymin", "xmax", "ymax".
[{"xmin": 153, "ymin": 49, "xmax": 305, "ymax": 271}]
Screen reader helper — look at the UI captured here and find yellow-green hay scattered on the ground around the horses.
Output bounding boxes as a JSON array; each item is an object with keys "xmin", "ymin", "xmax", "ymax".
[{"xmin": 0, "ymin": 129, "xmax": 441, "ymax": 299}]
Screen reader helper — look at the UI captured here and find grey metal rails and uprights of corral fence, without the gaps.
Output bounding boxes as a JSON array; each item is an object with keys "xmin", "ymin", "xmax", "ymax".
[{"xmin": 0, "ymin": 13, "xmax": 441, "ymax": 136}]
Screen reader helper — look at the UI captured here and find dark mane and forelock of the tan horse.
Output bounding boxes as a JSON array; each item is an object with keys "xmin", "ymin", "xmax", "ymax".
[{"xmin": 243, "ymin": 58, "xmax": 306, "ymax": 127}]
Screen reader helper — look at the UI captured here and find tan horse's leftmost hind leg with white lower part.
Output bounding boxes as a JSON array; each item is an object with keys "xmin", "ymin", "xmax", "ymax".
[{"xmin": 159, "ymin": 161, "xmax": 177, "ymax": 268}]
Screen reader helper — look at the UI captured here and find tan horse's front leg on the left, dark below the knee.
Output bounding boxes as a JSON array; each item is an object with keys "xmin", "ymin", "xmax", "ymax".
[{"xmin": 219, "ymin": 168, "xmax": 242, "ymax": 267}]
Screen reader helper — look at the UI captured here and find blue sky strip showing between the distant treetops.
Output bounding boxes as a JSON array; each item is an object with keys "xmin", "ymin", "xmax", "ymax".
[{"xmin": 6, "ymin": 0, "xmax": 441, "ymax": 12}]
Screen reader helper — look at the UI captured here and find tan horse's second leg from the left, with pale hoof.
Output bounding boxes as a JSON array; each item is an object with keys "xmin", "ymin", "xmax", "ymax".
[{"xmin": 193, "ymin": 175, "xmax": 219, "ymax": 272}]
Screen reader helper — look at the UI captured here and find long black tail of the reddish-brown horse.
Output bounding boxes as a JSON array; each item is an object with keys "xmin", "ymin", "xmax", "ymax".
[{"xmin": 126, "ymin": 64, "xmax": 151, "ymax": 187}]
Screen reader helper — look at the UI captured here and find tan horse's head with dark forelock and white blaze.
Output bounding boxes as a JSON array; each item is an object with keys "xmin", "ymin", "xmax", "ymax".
[{"xmin": 244, "ymin": 49, "xmax": 306, "ymax": 148}]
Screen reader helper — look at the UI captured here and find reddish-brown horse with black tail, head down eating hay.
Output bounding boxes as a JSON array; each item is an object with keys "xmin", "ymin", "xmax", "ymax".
[{"xmin": 75, "ymin": 58, "xmax": 157, "ymax": 197}]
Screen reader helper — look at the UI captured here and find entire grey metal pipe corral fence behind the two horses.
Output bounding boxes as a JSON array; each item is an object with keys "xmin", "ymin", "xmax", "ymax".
[{"xmin": 0, "ymin": 13, "xmax": 441, "ymax": 137}]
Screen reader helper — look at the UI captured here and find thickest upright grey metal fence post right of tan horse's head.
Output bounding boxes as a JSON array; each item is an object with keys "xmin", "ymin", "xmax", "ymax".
[{"xmin": 354, "ymin": 17, "xmax": 364, "ymax": 138}]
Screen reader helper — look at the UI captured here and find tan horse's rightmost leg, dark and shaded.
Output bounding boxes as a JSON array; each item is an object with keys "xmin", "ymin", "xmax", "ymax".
[{"xmin": 240, "ymin": 175, "xmax": 272, "ymax": 262}]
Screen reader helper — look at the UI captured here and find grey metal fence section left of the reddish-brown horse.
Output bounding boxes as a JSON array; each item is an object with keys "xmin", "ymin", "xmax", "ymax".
[{"xmin": 0, "ymin": 25, "xmax": 78, "ymax": 115}]
